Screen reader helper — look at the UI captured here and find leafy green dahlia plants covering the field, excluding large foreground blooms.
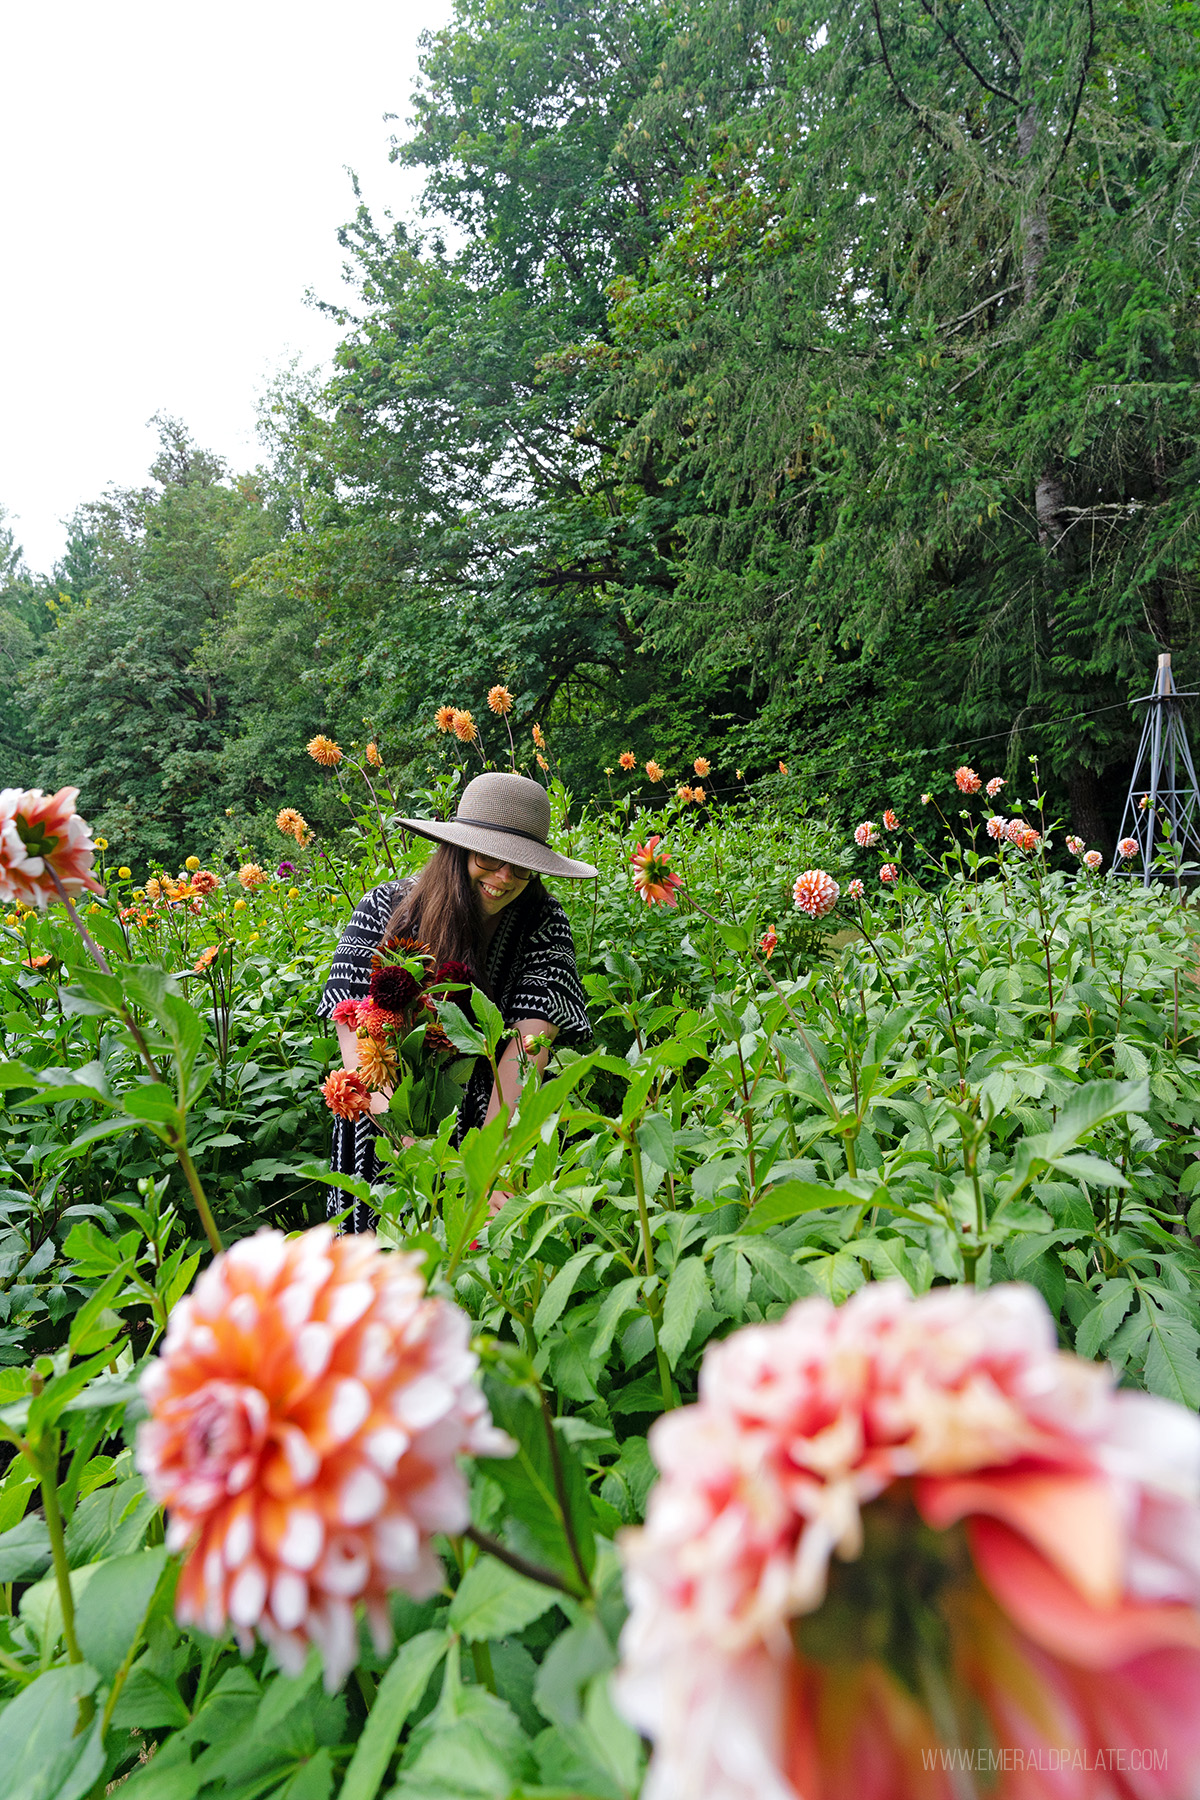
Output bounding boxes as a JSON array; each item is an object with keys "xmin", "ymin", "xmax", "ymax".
[{"xmin": 0, "ymin": 747, "xmax": 1200, "ymax": 1800}]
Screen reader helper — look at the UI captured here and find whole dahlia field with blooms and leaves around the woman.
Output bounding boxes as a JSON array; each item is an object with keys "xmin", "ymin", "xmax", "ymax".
[{"xmin": 0, "ymin": 738, "xmax": 1200, "ymax": 1800}]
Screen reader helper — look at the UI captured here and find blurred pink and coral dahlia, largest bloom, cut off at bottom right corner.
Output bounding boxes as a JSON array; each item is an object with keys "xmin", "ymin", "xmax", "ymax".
[{"xmin": 615, "ymin": 1282, "xmax": 1200, "ymax": 1800}]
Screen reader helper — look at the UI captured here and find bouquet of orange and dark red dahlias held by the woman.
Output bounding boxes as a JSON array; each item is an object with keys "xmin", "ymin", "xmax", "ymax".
[{"xmin": 324, "ymin": 938, "xmax": 475, "ymax": 1139}]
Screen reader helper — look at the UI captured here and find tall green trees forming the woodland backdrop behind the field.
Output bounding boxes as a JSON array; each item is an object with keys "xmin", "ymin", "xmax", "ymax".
[{"xmin": 0, "ymin": 0, "xmax": 1200, "ymax": 860}]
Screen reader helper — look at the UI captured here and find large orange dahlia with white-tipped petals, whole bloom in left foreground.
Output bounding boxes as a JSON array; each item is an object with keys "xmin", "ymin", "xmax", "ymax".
[{"xmin": 137, "ymin": 1226, "xmax": 513, "ymax": 1692}]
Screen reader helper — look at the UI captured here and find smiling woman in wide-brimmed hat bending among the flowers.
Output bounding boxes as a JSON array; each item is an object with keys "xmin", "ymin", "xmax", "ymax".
[{"xmin": 317, "ymin": 774, "xmax": 596, "ymax": 1231}]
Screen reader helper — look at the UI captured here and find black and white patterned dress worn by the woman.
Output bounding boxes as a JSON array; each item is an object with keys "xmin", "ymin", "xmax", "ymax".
[{"xmin": 317, "ymin": 880, "xmax": 592, "ymax": 1231}]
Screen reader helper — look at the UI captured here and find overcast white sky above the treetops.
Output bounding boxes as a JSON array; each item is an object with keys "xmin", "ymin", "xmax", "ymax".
[{"xmin": 0, "ymin": 0, "xmax": 450, "ymax": 572}]
